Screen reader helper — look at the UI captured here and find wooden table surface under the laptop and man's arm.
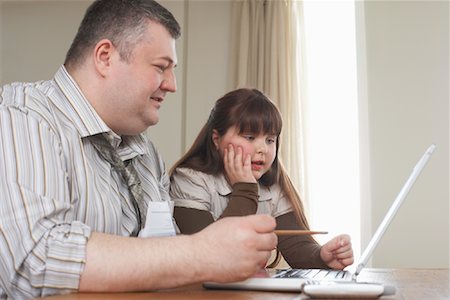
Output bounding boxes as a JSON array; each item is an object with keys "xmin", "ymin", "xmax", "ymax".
[{"xmin": 44, "ymin": 268, "xmax": 450, "ymax": 300}]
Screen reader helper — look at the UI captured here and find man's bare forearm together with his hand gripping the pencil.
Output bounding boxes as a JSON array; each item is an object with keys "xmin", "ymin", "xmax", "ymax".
[{"xmin": 79, "ymin": 215, "xmax": 277, "ymax": 292}]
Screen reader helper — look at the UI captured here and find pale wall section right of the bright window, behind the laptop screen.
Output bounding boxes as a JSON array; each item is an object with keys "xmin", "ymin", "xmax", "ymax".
[{"xmin": 365, "ymin": 1, "xmax": 449, "ymax": 267}]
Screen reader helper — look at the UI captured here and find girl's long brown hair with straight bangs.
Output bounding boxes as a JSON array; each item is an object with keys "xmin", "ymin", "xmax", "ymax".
[{"xmin": 169, "ymin": 88, "xmax": 309, "ymax": 228}]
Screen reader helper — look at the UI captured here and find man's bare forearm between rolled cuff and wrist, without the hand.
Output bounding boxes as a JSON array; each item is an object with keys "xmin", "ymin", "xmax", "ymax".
[{"xmin": 79, "ymin": 233, "xmax": 204, "ymax": 292}]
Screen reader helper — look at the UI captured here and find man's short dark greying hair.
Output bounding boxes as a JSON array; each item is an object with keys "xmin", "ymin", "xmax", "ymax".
[{"xmin": 64, "ymin": 0, "xmax": 181, "ymax": 68}]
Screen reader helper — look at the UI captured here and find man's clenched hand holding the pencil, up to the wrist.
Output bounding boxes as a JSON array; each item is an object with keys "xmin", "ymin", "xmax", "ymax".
[{"xmin": 195, "ymin": 215, "xmax": 278, "ymax": 282}]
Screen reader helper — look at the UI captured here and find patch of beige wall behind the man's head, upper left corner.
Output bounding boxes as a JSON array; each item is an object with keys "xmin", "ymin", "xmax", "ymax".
[{"xmin": 0, "ymin": 1, "xmax": 90, "ymax": 83}]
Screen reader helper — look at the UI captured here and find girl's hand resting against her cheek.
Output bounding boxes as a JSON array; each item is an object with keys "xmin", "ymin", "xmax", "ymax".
[{"xmin": 223, "ymin": 144, "xmax": 256, "ymax": 185}]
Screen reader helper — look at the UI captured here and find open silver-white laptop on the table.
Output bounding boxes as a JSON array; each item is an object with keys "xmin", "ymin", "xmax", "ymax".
[{"xmin": 203, "ymin": 144, "xmax": 436, "ymax": 292}]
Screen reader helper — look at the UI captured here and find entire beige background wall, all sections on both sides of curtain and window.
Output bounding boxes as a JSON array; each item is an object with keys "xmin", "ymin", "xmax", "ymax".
[{"xmin": 0, "ymin": 0, "xmax": 450, "ymax": 267}]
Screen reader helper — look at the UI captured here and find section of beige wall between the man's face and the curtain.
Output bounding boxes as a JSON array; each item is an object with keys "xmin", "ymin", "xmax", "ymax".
[{"xmin": 148, "ymin": 0, "xmax": 231, "ymax": 168}]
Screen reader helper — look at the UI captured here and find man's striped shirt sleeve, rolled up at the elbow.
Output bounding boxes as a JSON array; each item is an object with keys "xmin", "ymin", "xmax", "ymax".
[{"xmin": 0, "ymin": 106, "xmax": 91, "ymax": 298}]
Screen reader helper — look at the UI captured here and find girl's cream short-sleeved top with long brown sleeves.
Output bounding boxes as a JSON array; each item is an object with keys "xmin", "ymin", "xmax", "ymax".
[{"xmin": 170, "ymin": 168, "xmax": 328, "ymax": 268}]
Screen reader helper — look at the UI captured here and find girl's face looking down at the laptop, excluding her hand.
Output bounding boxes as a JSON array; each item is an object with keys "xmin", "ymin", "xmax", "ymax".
[{"xmin": 214, "ymin": 127, "xmax": 277, "ymax": 180}]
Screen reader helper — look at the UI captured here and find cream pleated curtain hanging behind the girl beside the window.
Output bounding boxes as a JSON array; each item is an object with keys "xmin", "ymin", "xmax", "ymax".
[{"xmin": 232, "ymin": 0, "xmax": 307, "ymax": 206}]
